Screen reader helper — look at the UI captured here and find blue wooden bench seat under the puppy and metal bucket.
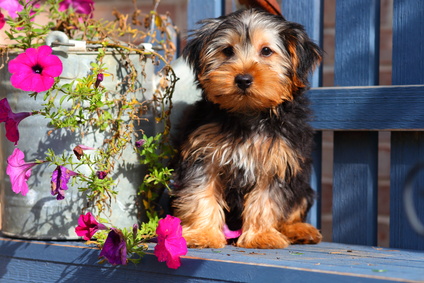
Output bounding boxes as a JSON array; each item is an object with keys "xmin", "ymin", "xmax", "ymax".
[{"xmin": 0, "ymin": 238, "xmax": 424, "ymax": 283}]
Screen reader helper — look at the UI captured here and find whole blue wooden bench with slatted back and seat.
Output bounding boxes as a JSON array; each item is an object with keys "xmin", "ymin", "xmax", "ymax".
[{"xmin": 0, "ymin": 0, "xmax": 424, "ymax": 282}]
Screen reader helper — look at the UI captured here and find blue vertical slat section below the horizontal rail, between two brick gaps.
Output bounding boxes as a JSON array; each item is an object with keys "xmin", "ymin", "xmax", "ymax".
[{"xmin": 333, "ymin": 132, "xmax": 378, "ymax": 245}]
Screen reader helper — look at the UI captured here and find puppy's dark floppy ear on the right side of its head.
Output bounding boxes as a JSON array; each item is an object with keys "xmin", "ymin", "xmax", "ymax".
[{"xmin": 280, "ymin": 22, "xmax": 322, "ymax": 87}]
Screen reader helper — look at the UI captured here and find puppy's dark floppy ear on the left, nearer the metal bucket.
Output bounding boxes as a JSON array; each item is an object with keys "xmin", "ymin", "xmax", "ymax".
[{"xmin": 182, "ymin": 18, "xmax": 221, "ymax": 78}]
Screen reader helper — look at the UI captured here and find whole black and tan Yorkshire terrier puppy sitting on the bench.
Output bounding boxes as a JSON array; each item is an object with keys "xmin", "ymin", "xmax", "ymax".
[{"xmin": 173, "ymin": 9, "xmax": 321, "ymax": 248}]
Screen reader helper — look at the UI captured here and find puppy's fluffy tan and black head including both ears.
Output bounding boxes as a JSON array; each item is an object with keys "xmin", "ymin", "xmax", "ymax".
[{"xmin": 183, "ymin": 9, "xmax": 321, "ymax": 113}]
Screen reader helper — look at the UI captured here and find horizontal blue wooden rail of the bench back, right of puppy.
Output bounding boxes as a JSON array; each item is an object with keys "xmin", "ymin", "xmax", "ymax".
[{"xmin": 308, "ymin": 86, "xmax": 424, "ymax": 131}]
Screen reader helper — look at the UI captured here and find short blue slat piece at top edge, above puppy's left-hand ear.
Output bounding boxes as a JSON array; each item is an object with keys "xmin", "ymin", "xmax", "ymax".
[{"xmin": 187, "ymin": 0, "xmax": 225, "ymax": 30}]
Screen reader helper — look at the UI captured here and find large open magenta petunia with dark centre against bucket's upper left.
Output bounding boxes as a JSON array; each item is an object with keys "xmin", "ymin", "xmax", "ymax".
[{"xmin": 9, "ymin": 45, "xmax": 63, "ymax": 92}]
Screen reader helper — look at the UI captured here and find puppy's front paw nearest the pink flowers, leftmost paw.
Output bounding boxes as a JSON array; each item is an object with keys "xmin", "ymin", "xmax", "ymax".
[{"xmin": 183, "ymin": 227, "xmax": 227, "ymax": 249}]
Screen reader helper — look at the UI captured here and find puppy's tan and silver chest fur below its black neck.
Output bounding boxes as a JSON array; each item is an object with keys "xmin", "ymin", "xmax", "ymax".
[{"xmin": 183, "ymin": 124, "xmax": 300, "ymax": 180}]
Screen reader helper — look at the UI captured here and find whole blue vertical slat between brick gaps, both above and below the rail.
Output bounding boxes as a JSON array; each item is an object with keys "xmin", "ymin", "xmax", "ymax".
[{"xmin": 333, "ymin": 0, "xmax": 380, "ymax": 245}]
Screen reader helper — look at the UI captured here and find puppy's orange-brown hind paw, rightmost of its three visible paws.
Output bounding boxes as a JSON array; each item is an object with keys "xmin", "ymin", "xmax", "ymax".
[{"xmin": 282, "ymin": 222, "xmax": 322, "ymax": 244}]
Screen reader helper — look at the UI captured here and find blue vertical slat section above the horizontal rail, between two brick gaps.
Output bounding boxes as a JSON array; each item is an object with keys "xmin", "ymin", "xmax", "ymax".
[{"xmin": 334, "ymin": 0, "xmax": 380, "ymax": 86}]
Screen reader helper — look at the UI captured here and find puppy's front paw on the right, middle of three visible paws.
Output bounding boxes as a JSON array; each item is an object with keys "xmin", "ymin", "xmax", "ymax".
[{"xmin": 237, "ymin": 229, "xmax": 290, "ymax": 249}]
